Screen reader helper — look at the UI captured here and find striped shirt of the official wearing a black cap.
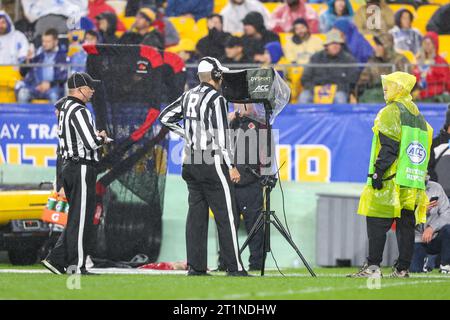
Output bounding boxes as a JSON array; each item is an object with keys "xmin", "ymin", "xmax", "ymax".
[{"xmin": 58, "ymin": 96, "xmax": 103, "ymax": 162}]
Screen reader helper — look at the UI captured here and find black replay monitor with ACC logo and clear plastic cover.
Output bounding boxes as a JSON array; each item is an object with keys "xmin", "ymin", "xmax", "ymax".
[{"xmin": 222, "ymin": 68, "xmax": 291, "ymax": 124}]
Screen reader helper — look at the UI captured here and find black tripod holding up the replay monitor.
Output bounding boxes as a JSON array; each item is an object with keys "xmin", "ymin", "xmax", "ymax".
[{"xmin": 239, "ymin": 103, "xmax": 316, "ymax": 277}]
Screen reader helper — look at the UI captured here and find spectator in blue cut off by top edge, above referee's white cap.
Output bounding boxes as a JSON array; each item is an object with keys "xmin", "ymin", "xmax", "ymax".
[{"xmin": 166, "ymin": 0, "xmax": 214, "ymax": 20}]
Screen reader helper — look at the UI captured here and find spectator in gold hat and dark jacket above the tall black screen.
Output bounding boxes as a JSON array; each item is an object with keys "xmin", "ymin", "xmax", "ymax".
[{"xmin": 119, "ymin": 8, "xmax": 164, "ymax": 50}]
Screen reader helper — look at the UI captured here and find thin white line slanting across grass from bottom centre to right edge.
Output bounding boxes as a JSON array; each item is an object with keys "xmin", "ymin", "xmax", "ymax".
[{"xmin": 217, "ymin": 280, "xmax": 448, "ymax": 300}]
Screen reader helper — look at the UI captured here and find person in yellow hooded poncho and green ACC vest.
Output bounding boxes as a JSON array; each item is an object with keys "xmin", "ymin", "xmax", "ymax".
[{"xmin": 350, "ymin": 72, "xmax": 433, "ymax": 278}]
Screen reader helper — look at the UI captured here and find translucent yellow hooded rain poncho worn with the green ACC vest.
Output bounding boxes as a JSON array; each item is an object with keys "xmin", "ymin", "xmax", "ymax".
[{"xmin": 358, "ymin": 72, "xmax": 433, "ymax": 224}]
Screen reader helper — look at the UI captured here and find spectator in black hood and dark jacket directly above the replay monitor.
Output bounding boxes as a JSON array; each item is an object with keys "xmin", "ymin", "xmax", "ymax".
[{"xmin": 242, "ymin": 12, "xmax": 280, "ymax": 57}]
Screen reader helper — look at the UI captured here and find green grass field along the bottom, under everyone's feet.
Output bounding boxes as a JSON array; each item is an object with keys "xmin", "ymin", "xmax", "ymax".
[{"xmin": 0, "ymin": 265, "xmax": 450, "ymax": 300}]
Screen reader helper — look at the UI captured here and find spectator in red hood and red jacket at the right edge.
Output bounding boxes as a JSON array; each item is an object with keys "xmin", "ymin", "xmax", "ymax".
[{"xmin": 414, "ymin": 31, "xmax": 450, "ymax": 102}]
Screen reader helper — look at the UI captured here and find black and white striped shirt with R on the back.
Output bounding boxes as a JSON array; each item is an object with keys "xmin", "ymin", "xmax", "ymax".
[{"xmin": 159, "ymin": 83, "xmax": 233, "ymax": 168}]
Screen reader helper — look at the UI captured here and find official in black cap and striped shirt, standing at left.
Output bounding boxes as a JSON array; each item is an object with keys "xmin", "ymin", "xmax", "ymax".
[{"xmin": 42, "ymin": 72, "xmax": 109, "ymax": 275}]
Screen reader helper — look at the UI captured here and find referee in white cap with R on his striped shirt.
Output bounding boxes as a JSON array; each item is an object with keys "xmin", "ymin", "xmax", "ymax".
[{"xmin": 159, "ymin": 57, "xmax": 248, "ymax": 276}]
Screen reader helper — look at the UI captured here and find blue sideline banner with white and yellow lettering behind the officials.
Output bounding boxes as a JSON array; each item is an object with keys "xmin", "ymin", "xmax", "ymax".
[{"xmin": 0, "ymin": 104, "xmax": 447, "ymax": 182}]
